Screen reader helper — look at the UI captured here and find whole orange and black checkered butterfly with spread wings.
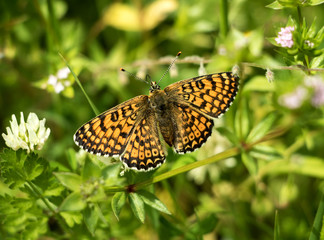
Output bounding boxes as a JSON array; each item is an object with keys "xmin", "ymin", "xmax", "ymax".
[{"xmin": 74, "ymin": 53, "xmax": 239, "ymax": 171}]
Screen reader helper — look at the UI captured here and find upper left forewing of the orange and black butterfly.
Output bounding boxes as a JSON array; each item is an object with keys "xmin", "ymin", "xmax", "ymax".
[{"xmin": 74, "ymin": 95, "xmax": 148, "ymax": 157}]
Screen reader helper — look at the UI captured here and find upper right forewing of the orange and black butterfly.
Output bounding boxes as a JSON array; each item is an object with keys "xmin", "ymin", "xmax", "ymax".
[{"xmin": 164, "ymin": 72, "xmax": 239, "ymax": 118}]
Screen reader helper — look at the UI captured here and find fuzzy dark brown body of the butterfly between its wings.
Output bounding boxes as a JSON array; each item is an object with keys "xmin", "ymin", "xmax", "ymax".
[{"xmin": 149, "ymin": 89, "xmax": 174, "ymax": 146}]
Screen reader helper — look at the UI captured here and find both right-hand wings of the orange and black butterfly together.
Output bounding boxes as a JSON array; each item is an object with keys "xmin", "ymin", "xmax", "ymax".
[{"xmin": 164, "ymin": 72, "xmax": 239, "ymax": 153}]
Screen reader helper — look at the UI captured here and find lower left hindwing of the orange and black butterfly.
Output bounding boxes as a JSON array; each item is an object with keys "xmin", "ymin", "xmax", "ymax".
[{"xmin": 121, "ymin": 109, "xmax": 165, "ymax": 171}]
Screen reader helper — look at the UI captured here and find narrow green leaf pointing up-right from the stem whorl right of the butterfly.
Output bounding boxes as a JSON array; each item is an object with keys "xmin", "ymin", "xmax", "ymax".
[{"xmin": 246, "ymin": 112, "xmax": 278, "ymax": 143}]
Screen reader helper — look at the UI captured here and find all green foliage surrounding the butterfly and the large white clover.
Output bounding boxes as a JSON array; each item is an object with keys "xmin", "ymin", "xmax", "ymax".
[{"xmin": 0, "ymin": 0, "xmax": 324, "ymax": 240}]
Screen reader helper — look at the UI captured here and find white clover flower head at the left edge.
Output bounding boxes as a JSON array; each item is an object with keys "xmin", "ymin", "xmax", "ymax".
[{"xmin": 2, "ymin": 112, "xmax": 51, "ymax": 153}]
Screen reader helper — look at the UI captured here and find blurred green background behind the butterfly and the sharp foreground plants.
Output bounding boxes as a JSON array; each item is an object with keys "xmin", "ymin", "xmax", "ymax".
[{"xmin": 0, "ymin": 0, "xmax": 324, "ymax": 239}]
